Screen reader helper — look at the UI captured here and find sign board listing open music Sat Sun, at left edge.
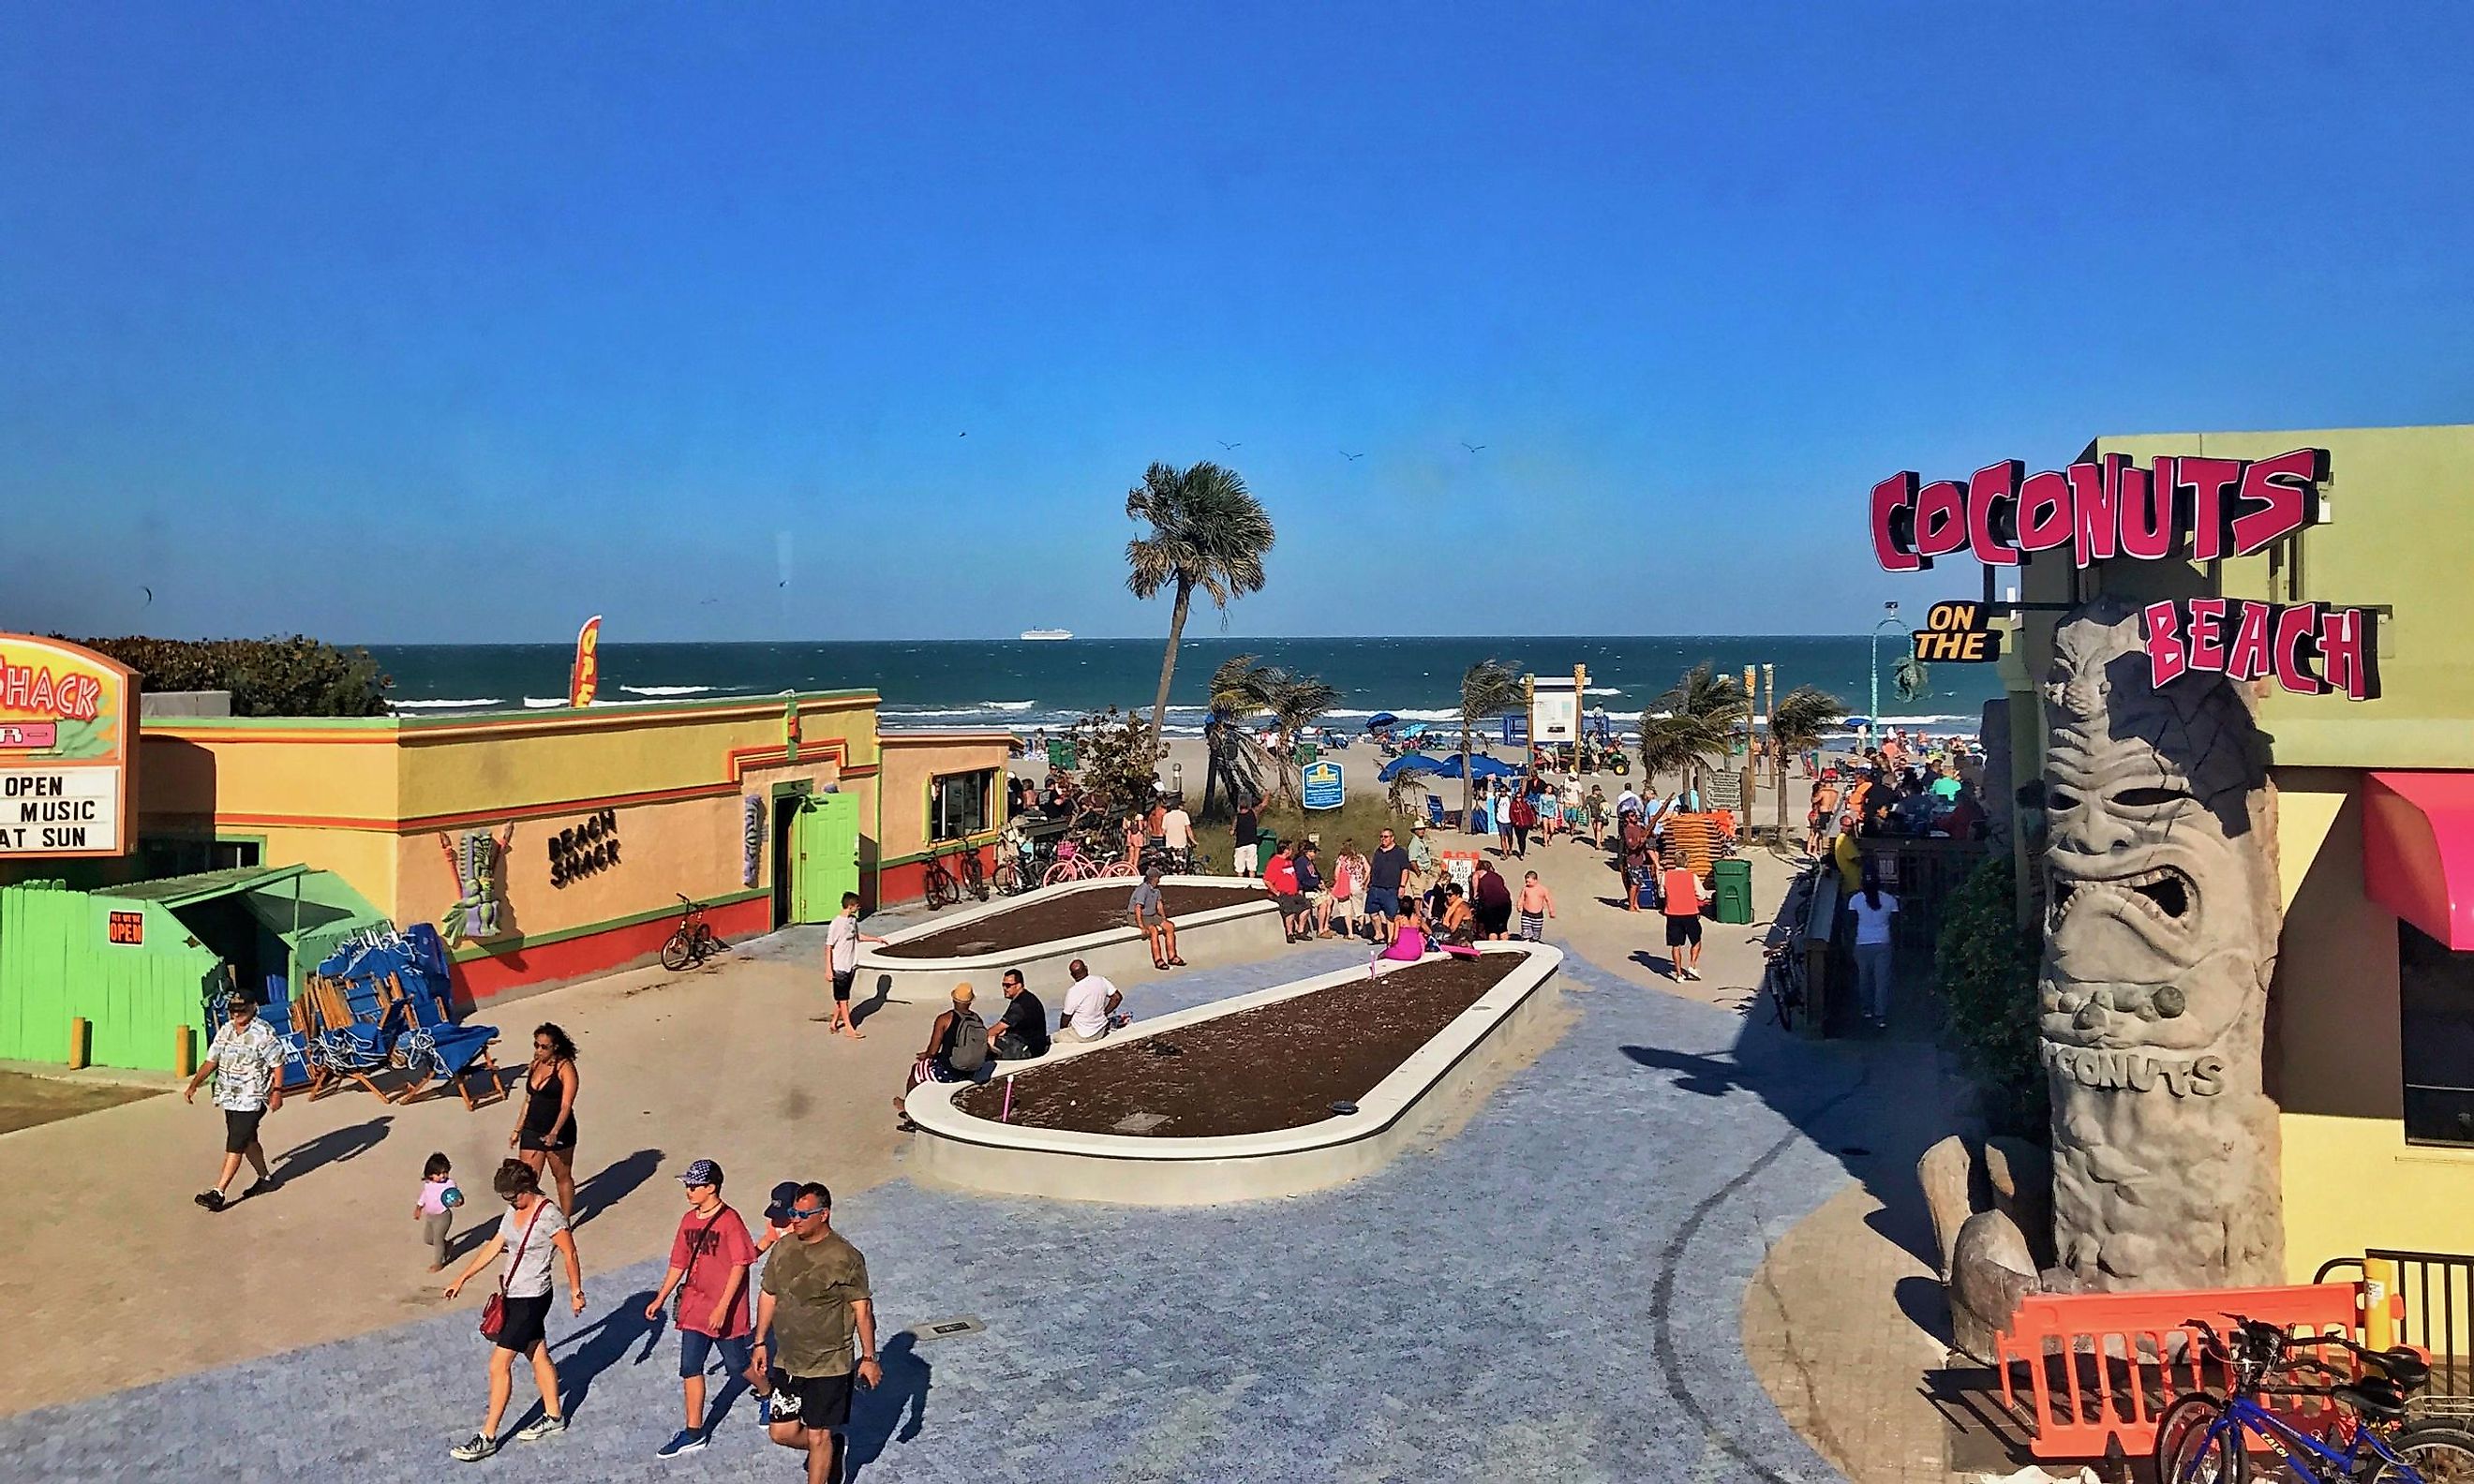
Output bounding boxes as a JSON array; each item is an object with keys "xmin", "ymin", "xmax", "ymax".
[{"xmin": 0, "ymin": 633, "xmax": 136, "ymax": 861}]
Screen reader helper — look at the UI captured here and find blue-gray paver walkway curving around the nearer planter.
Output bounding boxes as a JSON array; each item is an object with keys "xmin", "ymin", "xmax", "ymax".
[{"xmin": 0, "ymin": 944, "xmax": 1860, "ymax": 1484}]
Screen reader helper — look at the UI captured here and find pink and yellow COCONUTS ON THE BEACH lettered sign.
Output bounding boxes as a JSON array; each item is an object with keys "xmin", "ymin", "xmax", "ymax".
[{"xmin": 1872, "ymin": 448, "xmax": 2380, "ymax": 700}]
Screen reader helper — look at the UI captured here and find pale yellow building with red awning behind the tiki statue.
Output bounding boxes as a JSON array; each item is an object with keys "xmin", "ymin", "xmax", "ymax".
[{"xmin": 2004, "ymin": 425, "xmax": 2474, "ymax": 1282}]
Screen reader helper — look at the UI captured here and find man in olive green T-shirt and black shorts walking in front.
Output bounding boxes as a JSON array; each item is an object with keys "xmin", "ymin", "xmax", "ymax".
[{"xmin": 757, "ymin": 1182, "xmax": 886, "ymax": 1484}]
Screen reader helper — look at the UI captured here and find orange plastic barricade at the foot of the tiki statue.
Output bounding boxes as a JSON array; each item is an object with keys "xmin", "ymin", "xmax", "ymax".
[{"xmin": 1994, "ymin": 1284, "xmax": 2362, "ymax": 1460}]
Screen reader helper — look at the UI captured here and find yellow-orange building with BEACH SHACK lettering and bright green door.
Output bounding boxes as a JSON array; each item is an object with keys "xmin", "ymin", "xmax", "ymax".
[{"xmin": 12, "ymin": 690, "xmax": 1012, "ymax": 1000}]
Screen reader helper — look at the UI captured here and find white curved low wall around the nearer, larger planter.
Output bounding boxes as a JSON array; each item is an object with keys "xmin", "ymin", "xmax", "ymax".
[{"xmin": 908, "ymin": 942, "xmax": 1563, "ymax": 1205}]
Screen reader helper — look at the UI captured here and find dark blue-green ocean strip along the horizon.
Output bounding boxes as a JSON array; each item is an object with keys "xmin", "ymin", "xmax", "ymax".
[{"xmin": 371, "ymin": 635, "xmax": 1999, "ymax": 735}]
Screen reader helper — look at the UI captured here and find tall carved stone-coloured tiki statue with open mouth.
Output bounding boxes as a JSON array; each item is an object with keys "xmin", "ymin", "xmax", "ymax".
[{"xmin": 2038, "ymin": 599, "xmax": 2286, "ymax": 1288}]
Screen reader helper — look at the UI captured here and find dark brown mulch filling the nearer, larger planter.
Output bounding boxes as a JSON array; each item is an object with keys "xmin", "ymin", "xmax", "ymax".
[{"xmin": 955, "ymin": 952, "xmax": 1529, "ymax": 1137}]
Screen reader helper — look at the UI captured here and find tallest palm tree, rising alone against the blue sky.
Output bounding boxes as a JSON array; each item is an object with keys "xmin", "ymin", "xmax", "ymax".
[{"xmin": 1125, "ymin": 463, "xmax": 1272, "ymax": 747}]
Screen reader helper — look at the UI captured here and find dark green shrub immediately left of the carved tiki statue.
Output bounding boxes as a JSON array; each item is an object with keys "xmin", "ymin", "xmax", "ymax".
[{"xmin": 1934, "ymin": 855, "xmax": 2051, "ymax": 1143}]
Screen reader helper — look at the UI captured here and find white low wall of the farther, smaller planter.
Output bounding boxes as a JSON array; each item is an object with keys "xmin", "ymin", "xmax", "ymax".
[{"xmin": 851, "ymin": 876, "xmax": 1287, "ymax": 1014}]
